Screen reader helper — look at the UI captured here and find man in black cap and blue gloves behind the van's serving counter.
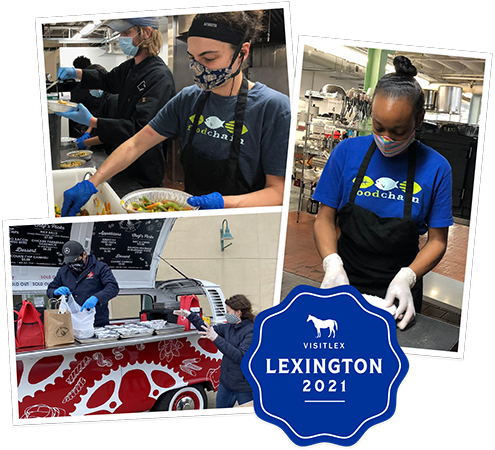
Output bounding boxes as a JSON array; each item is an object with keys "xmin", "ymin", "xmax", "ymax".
[{"xmin": 46, "ymin": 241, "xmax": 119, "ymax": 327}]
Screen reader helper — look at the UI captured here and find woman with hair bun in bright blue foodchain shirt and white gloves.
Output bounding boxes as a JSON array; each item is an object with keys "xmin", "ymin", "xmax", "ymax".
[{"xmin": 313, "ymin": 56, "xmax": 453, "ymax": 329}]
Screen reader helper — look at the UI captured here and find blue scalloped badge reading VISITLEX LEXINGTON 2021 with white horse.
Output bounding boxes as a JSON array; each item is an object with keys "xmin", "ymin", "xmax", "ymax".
[{"xmin": 242, "ymin": 286, "xmax": 409, "ymax": 446}]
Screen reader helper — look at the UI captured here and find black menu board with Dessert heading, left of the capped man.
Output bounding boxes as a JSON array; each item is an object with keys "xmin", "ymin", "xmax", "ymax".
[{"xmin": 9, "ymin": 224, "xmax": 72, "ymax": 267}]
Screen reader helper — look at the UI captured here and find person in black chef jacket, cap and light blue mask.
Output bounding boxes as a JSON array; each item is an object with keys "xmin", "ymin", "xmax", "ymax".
[{"xmin": 57, "ymin": 17, "xmax": 175, "ymax": 208}]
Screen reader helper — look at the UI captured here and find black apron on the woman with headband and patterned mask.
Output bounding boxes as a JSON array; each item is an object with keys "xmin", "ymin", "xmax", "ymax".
[{"xmin": 180, "ymin": 77, "xmax": 253, "ymax": 195}]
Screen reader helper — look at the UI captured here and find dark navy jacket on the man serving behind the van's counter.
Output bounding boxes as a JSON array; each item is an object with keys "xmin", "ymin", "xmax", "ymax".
[{"xmin": 46, "ymin": 255, "xmax": 119, "ymax": 327}]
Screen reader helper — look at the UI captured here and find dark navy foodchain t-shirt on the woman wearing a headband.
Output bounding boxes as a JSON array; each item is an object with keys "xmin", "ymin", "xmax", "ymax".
[{"xmin": 149, "ymin": 83, "xmax": 290, "ymax": 185}]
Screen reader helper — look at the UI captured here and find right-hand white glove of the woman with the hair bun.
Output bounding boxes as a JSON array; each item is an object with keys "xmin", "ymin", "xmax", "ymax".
[{"xmin": 385, "ymin": 267, "xmax": 416, "ymax": 330}]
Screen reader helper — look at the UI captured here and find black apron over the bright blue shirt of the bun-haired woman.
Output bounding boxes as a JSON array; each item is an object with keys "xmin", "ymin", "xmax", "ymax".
[{"xmin": 337, "ymin": 140, "xmax": 423, "ymax": 311}]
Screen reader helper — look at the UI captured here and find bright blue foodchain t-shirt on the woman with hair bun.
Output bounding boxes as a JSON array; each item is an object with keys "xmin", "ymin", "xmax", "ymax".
[{"xmin": 313, "ymin": 135, "xmax": 453, "ymax": 234}]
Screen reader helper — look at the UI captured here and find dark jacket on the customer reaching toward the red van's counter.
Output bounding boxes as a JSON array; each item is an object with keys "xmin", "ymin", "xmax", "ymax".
[{"xmin": 188, "ymin": 312, "xmax": 254, "ymax": 392}]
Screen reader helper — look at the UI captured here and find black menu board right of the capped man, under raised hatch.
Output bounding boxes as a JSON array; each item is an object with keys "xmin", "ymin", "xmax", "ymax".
[{"xmin": 91, "ymin": 219, "xmax": 165, "ymax": 270}]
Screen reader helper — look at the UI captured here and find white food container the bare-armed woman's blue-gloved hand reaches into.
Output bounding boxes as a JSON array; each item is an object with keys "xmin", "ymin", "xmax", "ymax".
[{"xmin": 52, "ymin": 168, "xmax": 124, "ymax": 216}]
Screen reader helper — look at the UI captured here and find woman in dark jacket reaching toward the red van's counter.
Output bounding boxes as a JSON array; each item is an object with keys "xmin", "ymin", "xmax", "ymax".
[{"xmin": 174, "ymin": 295, "xmax": 255, "ymax": 408}]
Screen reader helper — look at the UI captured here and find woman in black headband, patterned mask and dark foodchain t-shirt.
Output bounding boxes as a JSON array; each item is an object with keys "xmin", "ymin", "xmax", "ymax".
[{"xmin": 62, "ymin": 11, "xmax": 290, "ymax": 212}]
